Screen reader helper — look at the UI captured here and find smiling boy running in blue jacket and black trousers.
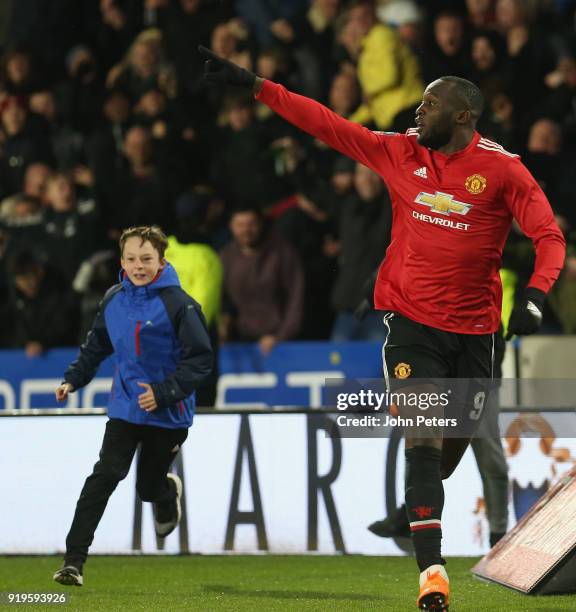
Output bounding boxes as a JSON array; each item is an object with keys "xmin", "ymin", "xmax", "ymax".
[{"xmin": 54, "ymin": 227, "xmax": 212, "ymax": 586}]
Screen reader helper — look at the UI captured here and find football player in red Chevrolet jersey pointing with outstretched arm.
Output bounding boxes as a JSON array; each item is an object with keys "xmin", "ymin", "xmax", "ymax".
[{"xmin": 200, "ymin": 47, "xmax": 565, "ymax": 610}]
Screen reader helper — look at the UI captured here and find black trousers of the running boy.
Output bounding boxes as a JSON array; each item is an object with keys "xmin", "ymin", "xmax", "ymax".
[{"xmin": 66, "ymin": 419, "xmax": 188, "ymax": 565}]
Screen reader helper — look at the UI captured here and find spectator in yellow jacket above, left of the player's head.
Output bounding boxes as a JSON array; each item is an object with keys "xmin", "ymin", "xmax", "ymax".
[{"xmin": 344, "ymin": 0, "xmax": 424, "ymax": 130}]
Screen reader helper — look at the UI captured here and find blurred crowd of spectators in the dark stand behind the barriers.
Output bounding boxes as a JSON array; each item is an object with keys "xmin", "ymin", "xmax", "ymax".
[{"xmin": 0, "ymin": 0, "xmax": 576, "ymax": 356}]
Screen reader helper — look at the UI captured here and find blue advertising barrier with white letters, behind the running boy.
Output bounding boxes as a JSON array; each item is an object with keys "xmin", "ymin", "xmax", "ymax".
[{"xmin": 0, "ymin": 342, "xmax": 382, "ymax": 409}]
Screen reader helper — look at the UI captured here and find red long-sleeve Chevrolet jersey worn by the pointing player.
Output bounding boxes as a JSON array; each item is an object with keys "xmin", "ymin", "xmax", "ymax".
[{"xmin": 257, "ymin": 80, "xmax": 566, "ymax": 334}]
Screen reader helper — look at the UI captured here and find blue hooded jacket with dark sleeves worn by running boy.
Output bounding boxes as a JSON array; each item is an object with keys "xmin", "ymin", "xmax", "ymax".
[{"xmin": 64, "ymin": 264, "xmax": 212, "ymax": 429}]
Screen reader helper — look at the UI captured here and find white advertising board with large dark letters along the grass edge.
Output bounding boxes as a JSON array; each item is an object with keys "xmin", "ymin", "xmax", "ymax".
[{"xmin": 0, "ymin": 413, "xmax": 576, "ymax": 555}]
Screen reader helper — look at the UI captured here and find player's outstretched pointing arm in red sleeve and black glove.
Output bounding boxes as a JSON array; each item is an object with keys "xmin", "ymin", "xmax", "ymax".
[{"xmin": 198, "ymin": 46, "xmax": 387, "ymax": 174}]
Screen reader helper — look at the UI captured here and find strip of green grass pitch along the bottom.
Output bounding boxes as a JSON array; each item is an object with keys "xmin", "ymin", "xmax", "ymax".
[{"xmin": 0, "ymin": 555, "xmax": 576, "ymax": 612}]
